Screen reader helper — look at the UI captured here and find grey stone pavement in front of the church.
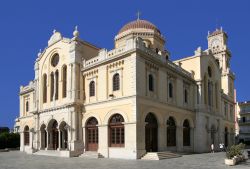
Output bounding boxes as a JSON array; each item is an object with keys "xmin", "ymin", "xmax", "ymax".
[{"xmin": 0, "ymin": 151, "xmax": 250, "ymax": 169}]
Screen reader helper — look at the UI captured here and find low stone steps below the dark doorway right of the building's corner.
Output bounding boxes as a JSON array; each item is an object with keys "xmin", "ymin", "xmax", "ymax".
[{"xmin": 141, "ymin": 151, "xmax": 181, "ymax": 160}]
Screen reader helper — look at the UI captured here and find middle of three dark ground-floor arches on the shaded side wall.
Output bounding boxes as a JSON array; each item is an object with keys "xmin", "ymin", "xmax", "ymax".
[{"xmin": 167, "ymin": 117, "xmax": 176, "ymax": 146}]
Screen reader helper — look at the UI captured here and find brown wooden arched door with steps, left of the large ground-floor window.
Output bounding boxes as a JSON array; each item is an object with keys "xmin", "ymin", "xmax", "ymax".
[{"xmin": 86, "ymin": 117, "xmax": 98, "ymax": 151}]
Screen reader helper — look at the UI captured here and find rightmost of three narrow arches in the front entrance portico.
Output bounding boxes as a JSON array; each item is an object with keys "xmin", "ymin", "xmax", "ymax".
[{"xmin": 59, "ymin": 121, "xmax": 68, "ymax": 149}]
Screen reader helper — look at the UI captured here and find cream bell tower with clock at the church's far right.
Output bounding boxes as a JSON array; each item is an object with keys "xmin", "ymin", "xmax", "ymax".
[{"xmin": 207, "ymin": 27, "xmax": 235, "ymax": 97}]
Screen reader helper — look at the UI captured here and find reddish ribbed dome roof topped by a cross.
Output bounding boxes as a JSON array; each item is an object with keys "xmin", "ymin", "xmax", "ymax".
[{"xmin": 119, "ymin": 19, "xmax": 161, "ymax": 34}]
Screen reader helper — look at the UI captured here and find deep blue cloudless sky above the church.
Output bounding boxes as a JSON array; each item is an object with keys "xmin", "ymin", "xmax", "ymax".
[{"xmin": 0, "ymin": 0, "xmax": 250, "ymax": 128}]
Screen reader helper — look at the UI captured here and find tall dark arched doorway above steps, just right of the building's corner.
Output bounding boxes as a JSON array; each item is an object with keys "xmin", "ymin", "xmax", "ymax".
[{"xmin": 145, "ymin": 113, "xmax": 158, "ymax": 152}]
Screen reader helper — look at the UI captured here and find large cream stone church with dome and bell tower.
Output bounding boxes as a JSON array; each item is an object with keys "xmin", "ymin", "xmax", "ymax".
[{"xmin": 15, "ymin": 18, "xmax": 235, "ymax": 159}]
